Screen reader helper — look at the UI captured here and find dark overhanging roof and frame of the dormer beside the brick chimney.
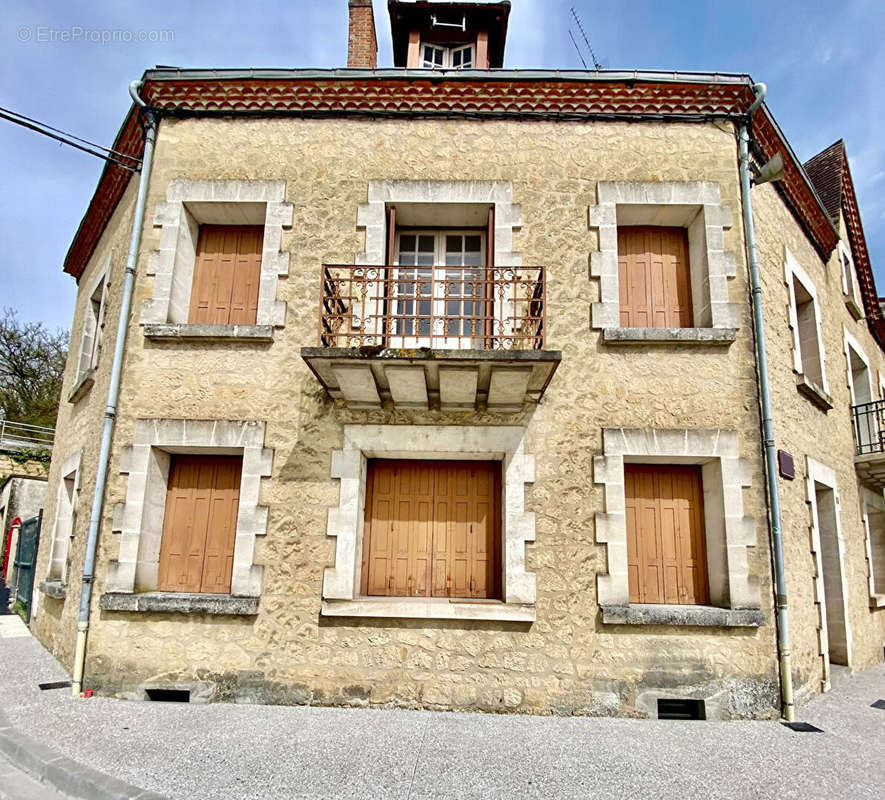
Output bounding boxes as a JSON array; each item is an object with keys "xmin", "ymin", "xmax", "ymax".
[{"xmin": 387, "ymin": 0, "xmax": 510, "ymax": 68}]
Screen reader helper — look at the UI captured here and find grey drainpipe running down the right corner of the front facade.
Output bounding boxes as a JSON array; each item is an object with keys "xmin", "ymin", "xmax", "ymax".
[{"xmin": 739, "ymin": 83, "xmax": 795, "ymax": 722}]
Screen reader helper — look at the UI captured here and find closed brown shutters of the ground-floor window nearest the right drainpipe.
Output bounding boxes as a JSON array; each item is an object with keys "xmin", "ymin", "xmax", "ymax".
[{"xmin": 624, "ymin": 464, "xmax": 710, "ymax": 605}]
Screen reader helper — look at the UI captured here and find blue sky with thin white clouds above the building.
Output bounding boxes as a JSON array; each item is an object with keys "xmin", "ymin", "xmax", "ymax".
[{"xmin": 0, "ymin": 0, "xmax": 885, "ymax": 330}]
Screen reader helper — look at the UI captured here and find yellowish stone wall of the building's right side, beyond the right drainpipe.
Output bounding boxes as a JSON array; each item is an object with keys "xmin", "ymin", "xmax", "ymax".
[{"xmin": 753, "ymin": 186, "xmax": 885, "ymax": 697}]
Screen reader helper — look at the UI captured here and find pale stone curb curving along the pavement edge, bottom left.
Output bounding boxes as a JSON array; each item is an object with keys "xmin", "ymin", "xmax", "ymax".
[{"xmin": 0, "ymin": 711, "xmax": 168, "ymax": 800}]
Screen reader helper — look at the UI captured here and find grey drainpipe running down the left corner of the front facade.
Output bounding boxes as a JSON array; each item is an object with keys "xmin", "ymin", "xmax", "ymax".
[{"xmin": 72, "ymin": 81, "xmax": 157, "ymax": 697}]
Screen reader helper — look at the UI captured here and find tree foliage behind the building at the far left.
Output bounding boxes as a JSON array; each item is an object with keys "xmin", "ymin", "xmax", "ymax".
[{"xmin": 0, "ymin": 308, "xmax": 69, "ymax": 427}]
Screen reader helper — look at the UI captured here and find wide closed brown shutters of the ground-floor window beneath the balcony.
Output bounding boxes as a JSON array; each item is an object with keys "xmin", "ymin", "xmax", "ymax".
[{"xmin": 362, "ymin": 460, "xmax": 501, "ymax": 598}]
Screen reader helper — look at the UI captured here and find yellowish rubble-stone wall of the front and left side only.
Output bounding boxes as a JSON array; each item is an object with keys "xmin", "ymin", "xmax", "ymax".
[{"xmin": 35, "ymin": 119, "xmax": 780, "ymax": 717}]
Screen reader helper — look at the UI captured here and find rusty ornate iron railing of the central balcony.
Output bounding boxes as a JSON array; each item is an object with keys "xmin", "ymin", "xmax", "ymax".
[{"xmin": 319, "ymin": 264, "xmax": 545, "ymax": 350}]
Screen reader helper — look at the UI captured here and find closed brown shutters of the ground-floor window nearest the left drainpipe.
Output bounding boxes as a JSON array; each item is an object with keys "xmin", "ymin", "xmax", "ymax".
[{"xmin": 157, "ymin": 456, "xmax": 242, "ymax": 594}]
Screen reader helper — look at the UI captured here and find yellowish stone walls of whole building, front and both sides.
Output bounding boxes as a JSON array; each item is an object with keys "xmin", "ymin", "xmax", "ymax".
[{"xmin": 25, "ymin": 108, "xmax": 885, "ymax": 718}]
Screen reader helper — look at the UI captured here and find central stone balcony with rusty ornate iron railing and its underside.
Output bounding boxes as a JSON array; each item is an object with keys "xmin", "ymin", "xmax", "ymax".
[{"xmin": 301, "ymin": 265, "xmax": 562, "ymax": 413}]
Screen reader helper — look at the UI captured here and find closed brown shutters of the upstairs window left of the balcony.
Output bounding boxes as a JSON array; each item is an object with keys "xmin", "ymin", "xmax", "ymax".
[{"xmin": 189, "ymin": 225, "xmax": 264, "ymax": 325}]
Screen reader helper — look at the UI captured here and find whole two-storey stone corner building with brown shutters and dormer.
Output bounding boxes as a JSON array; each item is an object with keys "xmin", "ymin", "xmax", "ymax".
[{"xmin": 33, "ymin": 0, "xmax": 885, "ymax": 718}]
